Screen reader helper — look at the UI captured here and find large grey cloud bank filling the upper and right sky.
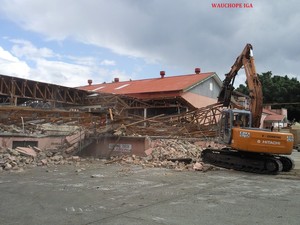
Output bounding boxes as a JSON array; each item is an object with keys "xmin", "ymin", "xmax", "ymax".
[{"xmin": 0, "ymin": 0, "xmax": 300, "ymax": 86}]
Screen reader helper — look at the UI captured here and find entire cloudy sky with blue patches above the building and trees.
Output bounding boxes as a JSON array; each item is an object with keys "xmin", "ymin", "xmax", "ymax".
[{"xmin": 0, "ymin": 0, "xmax": 300, "ymax": 87}]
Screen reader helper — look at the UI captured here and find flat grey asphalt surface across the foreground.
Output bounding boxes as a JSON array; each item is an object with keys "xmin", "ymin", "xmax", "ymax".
[{"xmin": 0, "ymin": 152, "xmax": 300, "ymax": 225}]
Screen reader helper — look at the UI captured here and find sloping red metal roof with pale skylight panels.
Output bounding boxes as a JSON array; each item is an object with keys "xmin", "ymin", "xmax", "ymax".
[{"xmin": 78, "ymin": 72, "xmax": 215, "ymax": 95}]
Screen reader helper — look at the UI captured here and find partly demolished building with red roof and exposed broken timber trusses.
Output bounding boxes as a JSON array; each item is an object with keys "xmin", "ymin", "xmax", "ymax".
[{"xmin": 0, "ymin": 68, "xmax": 222, "ymax": 161}]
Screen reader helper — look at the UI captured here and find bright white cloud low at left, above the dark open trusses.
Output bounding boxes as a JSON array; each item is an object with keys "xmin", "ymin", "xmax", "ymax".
[{"xmin": 0, "ymin": 44, "xmax": 91, "ymax": 87}]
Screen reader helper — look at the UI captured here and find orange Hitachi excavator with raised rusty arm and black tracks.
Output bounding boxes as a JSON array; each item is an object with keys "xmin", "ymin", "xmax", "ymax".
[{"xmin": 201, "ymin": 44, "xmax": 294, "ymax": 174}]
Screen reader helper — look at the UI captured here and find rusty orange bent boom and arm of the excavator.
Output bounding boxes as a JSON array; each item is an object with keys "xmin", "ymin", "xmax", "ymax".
[{"xmin": 218, "ymin": 44, "xmax": 263, "ymax": 127}]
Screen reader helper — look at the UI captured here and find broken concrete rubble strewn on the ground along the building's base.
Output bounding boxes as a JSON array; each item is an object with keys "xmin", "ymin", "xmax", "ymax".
[{"xmin": 0, "ymin": 139, "xmax": 220, "ymax": 171}]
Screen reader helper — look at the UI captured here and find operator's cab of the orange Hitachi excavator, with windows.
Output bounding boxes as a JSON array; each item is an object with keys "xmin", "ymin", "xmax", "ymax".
[{"xmin": 219, "ymin": 109, "xmax": 252, "ymax": 144}]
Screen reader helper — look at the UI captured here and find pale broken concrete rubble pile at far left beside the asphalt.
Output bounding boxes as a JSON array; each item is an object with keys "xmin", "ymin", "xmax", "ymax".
[{"xmin": 0, "ymin": 147, "xmax": 84, "ymax": 171}]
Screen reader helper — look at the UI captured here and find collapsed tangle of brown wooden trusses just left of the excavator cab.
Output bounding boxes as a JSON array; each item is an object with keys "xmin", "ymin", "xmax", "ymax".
[{"xmin": 105, "ymin": 103, "xmax": 223, "ymax": 138}]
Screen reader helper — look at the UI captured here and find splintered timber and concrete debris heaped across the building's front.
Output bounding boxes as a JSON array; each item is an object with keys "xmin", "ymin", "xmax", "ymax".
[{"xmin": 0, "ymin": 98, "xmax": 225, "ymax": 174}]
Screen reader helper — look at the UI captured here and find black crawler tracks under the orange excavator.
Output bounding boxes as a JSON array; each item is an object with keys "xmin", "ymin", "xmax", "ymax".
[{"xmin": 201, "ymin": 148, "xmax": 294, "ymax": 175}]
